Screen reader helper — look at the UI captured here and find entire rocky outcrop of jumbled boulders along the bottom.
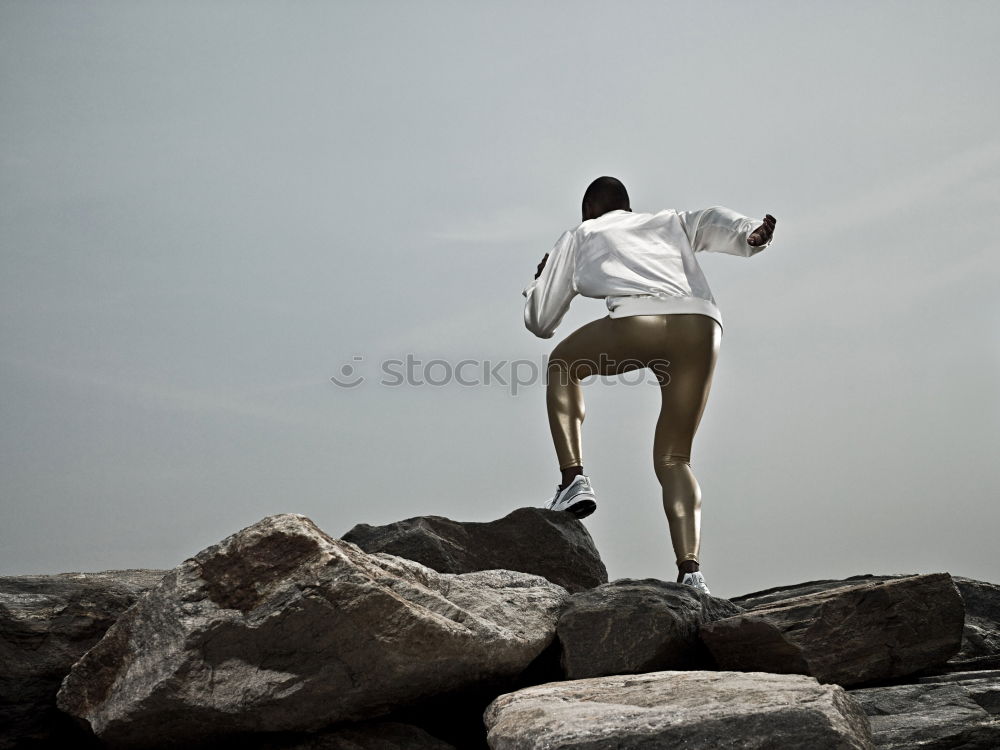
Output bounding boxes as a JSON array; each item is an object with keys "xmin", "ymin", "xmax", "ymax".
[{"xmin": 0, "ymin": 508, "xmax": 1000, "ymax": 750}]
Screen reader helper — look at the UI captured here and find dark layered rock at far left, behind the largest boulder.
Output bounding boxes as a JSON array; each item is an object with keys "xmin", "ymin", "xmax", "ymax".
[{"xmin": 0, "ymin": 570, "xmax": 166, "ymax": 750}]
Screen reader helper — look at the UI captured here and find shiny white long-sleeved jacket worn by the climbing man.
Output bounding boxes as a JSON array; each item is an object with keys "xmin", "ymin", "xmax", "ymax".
[{"xmin": 521, "ymin": 206, "xmax": 771, "ymax": 339}]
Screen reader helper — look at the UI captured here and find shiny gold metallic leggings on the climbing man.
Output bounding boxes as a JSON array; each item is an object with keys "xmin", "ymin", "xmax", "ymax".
[{"xmin": 546, "ymin": 313, "xmax": 722, "ymax": 565}]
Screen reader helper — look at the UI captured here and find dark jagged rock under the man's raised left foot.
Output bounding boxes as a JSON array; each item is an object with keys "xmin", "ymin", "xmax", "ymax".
[{"xmin": 342, "ymin": 507, "xmax": 608, "ymax": 592}]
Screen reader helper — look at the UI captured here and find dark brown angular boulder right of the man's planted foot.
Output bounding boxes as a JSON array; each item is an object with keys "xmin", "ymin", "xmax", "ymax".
[{"xmin": 699, "ymin": 573, "xmax": 964, "ymax": 686}]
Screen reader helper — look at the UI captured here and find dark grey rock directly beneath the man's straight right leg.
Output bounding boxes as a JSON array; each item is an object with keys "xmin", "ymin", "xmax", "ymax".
[{"xmin": 556, "ymin": 578, "xmax": 743, "ymax": 680}]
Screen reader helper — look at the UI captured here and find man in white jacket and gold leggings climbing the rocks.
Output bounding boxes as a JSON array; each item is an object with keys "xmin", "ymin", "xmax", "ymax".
[{"xmin": 522, "ymin": 177, "xmax": 777, "ymax": 593}]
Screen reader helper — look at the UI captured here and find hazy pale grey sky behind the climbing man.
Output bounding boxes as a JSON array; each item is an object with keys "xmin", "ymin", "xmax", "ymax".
[{"xmin": 0, "ymin": 0, "xmax": 1000, "ymax": 596}]
